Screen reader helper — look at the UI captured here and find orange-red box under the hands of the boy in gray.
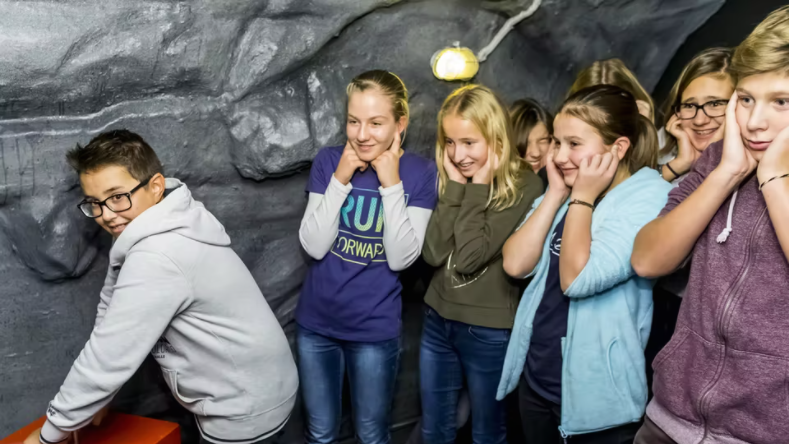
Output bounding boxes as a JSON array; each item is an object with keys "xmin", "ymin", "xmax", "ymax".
[{"xmin": 0, "ymin": 413, "xmax": 181, "ymax": 444}]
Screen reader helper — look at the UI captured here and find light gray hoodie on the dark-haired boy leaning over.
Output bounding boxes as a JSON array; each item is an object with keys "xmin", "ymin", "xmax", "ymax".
[{"xmin": 41, "ymin": 179, "xmax": 298, "ymax": 444}]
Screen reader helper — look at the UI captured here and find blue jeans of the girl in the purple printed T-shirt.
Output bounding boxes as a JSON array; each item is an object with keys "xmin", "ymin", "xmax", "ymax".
[{"xmin": 297, "ymin": 326, "xmax": 400, "ymax": 444}]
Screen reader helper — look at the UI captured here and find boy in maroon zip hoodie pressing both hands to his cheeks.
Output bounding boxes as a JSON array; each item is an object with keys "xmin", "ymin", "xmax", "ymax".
[{"xmin": 631, "ymin": 6, "xmax": 790, "ymax": 444}]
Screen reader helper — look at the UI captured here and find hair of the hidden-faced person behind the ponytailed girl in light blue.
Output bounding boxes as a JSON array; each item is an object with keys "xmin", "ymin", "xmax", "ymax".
[{"xmin": 567, "ymin": 59, "xmax": 656, "ymax": 122}]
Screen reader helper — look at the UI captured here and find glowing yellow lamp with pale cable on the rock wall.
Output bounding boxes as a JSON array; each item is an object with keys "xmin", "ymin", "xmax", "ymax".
[{"xmin": 431, "ymin": 0, "xmax": 541, "ymax": 81}]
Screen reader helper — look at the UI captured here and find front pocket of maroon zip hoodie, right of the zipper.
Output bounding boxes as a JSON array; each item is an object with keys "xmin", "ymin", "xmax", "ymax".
[{"xmin": 707, "ymin": 349, "xmax": 788, "ymax": 444}]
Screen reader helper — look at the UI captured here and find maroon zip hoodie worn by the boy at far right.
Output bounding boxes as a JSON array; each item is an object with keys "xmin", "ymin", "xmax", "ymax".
[{"xmin": 647, "ymin": 142, "xmax": 788, "ymax": 444}]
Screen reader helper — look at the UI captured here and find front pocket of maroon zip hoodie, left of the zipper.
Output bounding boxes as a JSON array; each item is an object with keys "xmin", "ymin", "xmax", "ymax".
[{"xmin": 653, "ymin": 327, "xmax": 724, "ymax": 425}]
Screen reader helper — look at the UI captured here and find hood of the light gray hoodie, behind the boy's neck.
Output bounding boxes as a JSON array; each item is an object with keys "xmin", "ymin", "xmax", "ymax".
[{"xmin": 110, "ymin": 178, "xmax": 230, "ymax": 266}]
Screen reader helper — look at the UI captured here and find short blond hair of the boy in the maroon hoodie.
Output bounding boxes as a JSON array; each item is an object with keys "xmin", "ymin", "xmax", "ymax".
[{"xmin": 732, "ymin": 6, "xmax": 788, "ymax": 82}]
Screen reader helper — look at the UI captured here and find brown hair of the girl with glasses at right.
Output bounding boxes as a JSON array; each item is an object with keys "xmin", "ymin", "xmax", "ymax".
[{"xmin": 658, "ymin": 48, "xmax": 732, "ymax": 157}]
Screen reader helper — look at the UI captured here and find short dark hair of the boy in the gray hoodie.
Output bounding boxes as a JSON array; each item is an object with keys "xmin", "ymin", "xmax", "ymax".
[{"xmin": 66, "ymin": 129, "xmax": 162, "ymax": 182}]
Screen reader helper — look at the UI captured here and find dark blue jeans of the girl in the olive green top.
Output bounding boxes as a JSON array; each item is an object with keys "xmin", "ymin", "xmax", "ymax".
[{"xmin": 420, "ymin": 307, "xmax": 510, "ymax": 444}]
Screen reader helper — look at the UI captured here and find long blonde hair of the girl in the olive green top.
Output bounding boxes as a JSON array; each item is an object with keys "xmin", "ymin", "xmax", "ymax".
[{"xmin": 436, "ymin": 85, "xmax": 526, "ymax": 211}]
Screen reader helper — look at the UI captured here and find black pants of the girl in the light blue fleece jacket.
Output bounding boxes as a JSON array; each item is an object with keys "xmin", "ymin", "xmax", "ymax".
[{"xmin": 518, "ymin": 377, "xmax": 640, "ymax": 444}]
